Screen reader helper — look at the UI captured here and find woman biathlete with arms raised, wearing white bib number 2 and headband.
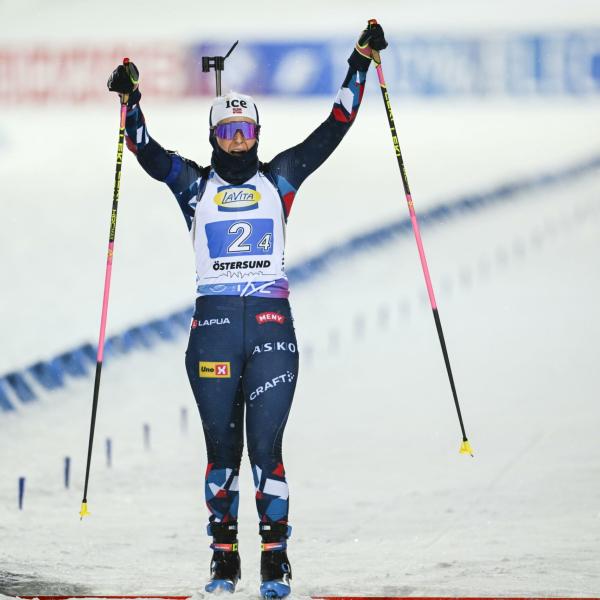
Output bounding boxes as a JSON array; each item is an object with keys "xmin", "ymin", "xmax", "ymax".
[{"xmin": 108, "ymin": 25, "xmax": 387, "ymax": 598}]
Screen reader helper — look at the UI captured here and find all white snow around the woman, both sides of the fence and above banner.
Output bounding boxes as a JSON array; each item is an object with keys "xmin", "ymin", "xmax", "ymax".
[{"xmin": 0, "ymin": 0, "xmax": 600, "ymax": 598}]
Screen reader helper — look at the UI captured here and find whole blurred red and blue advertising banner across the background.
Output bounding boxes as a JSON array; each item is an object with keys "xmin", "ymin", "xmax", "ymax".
[{"xmin": 0, "ymin": 30, "xmax": 600, "ymax": 104}]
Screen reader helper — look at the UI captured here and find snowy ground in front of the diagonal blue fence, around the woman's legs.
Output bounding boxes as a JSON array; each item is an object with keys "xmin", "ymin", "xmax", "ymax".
[{"xmin": 0, "ymin": 163, "xmax": 600, "ymax": 597}]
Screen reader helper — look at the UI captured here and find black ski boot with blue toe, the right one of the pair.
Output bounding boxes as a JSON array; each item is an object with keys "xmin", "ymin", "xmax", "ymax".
[{"xmin": 259, "ymin": 523, "xmax": 292, "ymax": 600}]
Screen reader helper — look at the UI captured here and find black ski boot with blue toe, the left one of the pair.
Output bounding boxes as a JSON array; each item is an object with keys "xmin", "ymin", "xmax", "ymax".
[{"xmin": 204, "ymin": 523, "xmax": 242, "ymax": 593}]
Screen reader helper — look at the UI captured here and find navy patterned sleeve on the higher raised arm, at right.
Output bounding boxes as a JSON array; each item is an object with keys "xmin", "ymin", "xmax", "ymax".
[{"xmin": 265, "ymin": 58, "xmax": 370, "ymax": 217}]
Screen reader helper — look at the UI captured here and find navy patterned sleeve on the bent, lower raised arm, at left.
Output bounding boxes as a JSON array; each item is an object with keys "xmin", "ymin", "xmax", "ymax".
[{"xmin": 125, "ymin": 93, "xmax": 205, "ymax": 229}]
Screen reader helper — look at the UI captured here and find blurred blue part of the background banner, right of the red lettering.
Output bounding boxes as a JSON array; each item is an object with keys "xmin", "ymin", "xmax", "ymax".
[{"xmin": 189, "ymin": 30, "xmax": 600, "ymax": 97}]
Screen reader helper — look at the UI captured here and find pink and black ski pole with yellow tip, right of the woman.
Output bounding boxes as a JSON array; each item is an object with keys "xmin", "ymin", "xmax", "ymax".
[{"xmin": 369, "ymin": 19, "xmax": 473, "ymax": 456}]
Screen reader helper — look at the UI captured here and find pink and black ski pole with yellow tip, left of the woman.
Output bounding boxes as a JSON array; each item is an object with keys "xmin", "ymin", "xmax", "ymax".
[{"xmin": 79, "ymin": 58, "xmax": 134, "ymax": 519}]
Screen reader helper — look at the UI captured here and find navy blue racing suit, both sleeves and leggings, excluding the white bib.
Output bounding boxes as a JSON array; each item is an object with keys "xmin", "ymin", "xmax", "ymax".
[{"xmin": 126, "ymin": 54, "xmax": 369, "ymax": 524}]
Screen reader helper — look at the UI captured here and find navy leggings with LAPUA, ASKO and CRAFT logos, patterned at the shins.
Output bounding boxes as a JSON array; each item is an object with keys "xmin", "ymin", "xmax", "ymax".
[{"xmin": 185, "ymin": 296, "xmax": 298, "ymax": 523}]
